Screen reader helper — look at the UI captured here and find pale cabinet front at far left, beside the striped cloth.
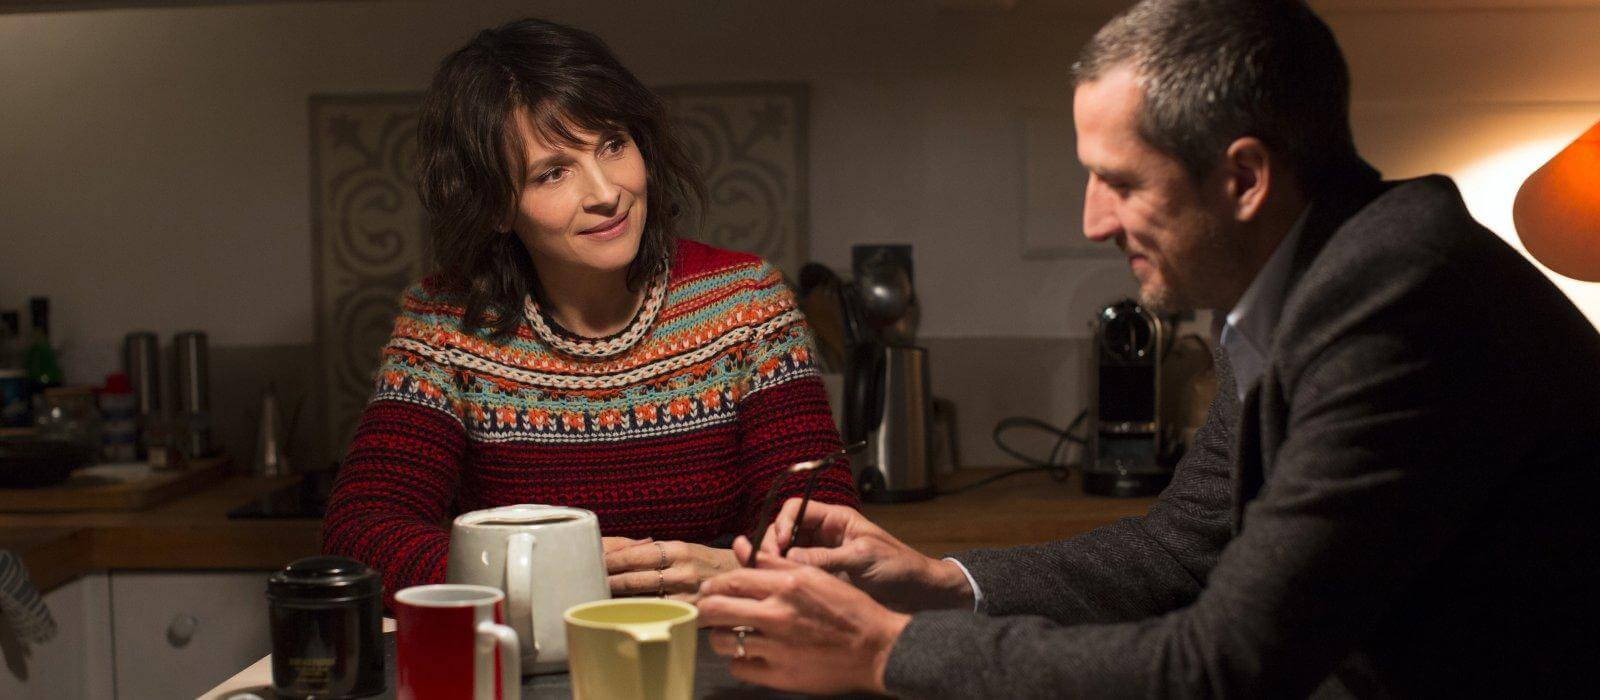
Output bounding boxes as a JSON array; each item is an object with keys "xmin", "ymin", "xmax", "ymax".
[{"xmin": 0, "ymin": 574, "xmax": 112, "ymax": 700}]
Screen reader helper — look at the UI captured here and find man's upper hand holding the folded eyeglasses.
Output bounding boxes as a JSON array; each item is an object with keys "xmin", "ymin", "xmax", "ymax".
[{"xmin": 748, "ymin": 499, "xmax": 973, "ymax": 612}]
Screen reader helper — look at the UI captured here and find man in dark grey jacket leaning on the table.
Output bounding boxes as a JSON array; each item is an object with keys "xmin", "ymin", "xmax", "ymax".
[{"xmin": 699, "ymin": 0, "xmax": 1600, "ymax": 697}]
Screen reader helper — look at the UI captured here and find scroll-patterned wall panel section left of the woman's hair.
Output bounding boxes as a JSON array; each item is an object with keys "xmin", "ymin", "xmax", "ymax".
[{"xmin": 310, "ymin": 93, "xmax": 427, "ymax": 455}]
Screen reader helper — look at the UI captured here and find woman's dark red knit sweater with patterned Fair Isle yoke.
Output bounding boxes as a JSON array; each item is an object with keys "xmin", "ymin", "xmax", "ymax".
[{"xmin": 323, "ymin": 240, "xmax": 856, "ymax": 596}]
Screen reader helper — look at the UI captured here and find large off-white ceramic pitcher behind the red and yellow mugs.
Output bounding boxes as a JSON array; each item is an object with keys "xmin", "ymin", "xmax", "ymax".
[{"xmin": 445, "ymin": 505, "xmax": 611, "ymax": 673}]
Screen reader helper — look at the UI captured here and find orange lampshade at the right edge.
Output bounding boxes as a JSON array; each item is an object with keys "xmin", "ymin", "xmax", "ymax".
[{"xmin": 1510, "ymin": 123, "xmax": 1600, "ymax": 281}]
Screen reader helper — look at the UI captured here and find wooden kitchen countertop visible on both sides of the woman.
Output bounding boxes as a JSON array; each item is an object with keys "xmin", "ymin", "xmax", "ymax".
[{"xmin": 0, "ymin": 468, "xmax": 1152, "ymax": 591}]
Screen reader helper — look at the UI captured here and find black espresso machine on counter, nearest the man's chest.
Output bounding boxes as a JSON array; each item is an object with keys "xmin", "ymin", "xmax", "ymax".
[{"xmin": 1083, "ymin": 299, "xmax": 1173, "ymax": 495}]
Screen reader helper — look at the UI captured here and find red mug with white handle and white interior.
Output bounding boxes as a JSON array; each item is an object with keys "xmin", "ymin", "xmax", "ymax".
[{"xmin": 394, "ymin": 583, "xmax": 522, "ymax": 700}]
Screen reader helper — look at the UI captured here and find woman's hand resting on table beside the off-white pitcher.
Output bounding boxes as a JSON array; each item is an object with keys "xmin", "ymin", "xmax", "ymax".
[{"xmin": 605, "ymin": 537, "xmax": 739, "ymax": 603}]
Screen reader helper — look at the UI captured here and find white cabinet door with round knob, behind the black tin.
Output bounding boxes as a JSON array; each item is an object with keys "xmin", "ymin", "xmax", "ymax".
[{"xmin": 110, "ymin": 571, "xmax": 272, "ymax": 700}]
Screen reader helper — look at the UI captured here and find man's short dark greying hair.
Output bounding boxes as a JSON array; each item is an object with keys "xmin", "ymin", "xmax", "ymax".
[{"xmin": 1072, "ymin": 0, "xmax": 1357, "ymax": 192}]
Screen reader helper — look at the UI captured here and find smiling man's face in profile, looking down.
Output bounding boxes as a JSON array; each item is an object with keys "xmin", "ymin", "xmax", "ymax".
[{"xmin": 1072, "ymin": 67, "xmax": 1245, "ymax": 313}]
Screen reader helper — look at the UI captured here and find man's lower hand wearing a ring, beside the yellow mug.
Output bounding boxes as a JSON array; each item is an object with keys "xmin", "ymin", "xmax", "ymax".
[{"xmin": 698, "ymin": 545, "xmax": 910, "ymax": 694}]
